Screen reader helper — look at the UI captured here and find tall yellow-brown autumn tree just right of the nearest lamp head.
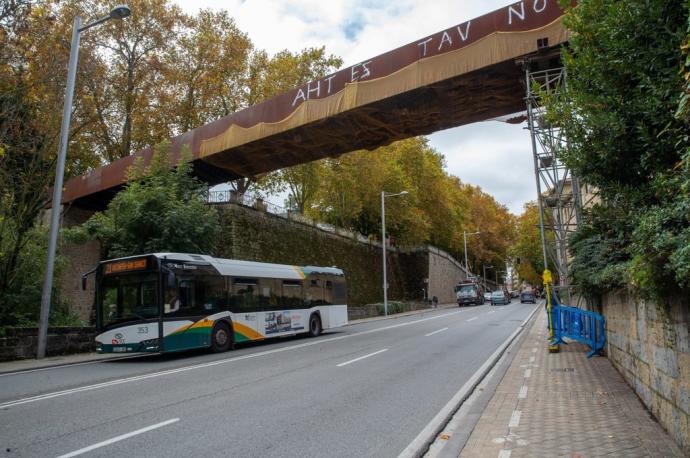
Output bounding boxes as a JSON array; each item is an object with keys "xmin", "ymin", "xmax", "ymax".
[{"xmin": 82, "ymin": 0, "xmax": 188, "ymax": 162}]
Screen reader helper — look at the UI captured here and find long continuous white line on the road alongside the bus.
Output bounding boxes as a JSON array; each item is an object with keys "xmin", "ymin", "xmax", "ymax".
[{"xmin": 0, "ymin": 310, "xmax": 464, "ymax": 409}]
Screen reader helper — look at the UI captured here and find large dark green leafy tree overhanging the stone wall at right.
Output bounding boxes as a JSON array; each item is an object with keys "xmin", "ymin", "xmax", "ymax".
[{"xmin": 547, "ymin": 0, "xmax": 689, "ymax": 295}]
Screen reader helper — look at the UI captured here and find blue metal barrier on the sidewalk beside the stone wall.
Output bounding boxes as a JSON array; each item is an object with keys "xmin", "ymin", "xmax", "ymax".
[{"xmin": 547, "ymin": 304, "xmax": 606, "ymax": 358}]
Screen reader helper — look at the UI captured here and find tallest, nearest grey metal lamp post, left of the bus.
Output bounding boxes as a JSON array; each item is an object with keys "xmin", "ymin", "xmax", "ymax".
[{"xmin": 36, "ymin": 5, "xmax": 131, "ymax": 358}]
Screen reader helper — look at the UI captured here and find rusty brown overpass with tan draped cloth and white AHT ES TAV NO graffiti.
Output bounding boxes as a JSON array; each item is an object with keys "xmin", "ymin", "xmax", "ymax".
[{"xmin": 63, "ymin": 0, "xmax": 569, "ymax": 209}]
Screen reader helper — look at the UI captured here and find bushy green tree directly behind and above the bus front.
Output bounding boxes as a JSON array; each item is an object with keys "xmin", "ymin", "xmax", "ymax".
[{"xmin": 69, "ymin": 143, "xmax": 220, "ymax": 258}]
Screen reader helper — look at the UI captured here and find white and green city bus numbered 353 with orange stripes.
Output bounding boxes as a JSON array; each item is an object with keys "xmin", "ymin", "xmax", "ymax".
[{"xmin": 82, "ymin": 253, "xmax": 347, "ymax": 353}]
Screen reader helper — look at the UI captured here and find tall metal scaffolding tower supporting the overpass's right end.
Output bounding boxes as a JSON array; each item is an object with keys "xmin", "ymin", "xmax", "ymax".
[{"xmin": 523, "ymin": 62, "xmax": 582, "ymax": 288}]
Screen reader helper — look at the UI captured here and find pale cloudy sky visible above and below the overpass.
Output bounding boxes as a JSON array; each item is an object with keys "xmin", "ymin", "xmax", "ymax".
[{"xmin": 175, "ymin": 0, "xmax": 532, "ymax": 214}]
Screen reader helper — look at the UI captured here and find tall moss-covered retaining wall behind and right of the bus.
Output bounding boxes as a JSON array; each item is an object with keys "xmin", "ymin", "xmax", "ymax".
[{"xmin": 216, "ymin": 204, "xmax": 429, "ymax": 306}]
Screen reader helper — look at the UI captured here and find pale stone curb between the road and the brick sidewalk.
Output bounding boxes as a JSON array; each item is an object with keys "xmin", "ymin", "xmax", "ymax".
[{"xmin": 398, "ymin": 304, "xmax": 541, "ymax": 458}]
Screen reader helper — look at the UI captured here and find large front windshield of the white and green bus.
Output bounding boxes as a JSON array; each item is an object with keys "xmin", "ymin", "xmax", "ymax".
[{"xmin": 98, "ymin": 273, "xmax": 159, "ymax": 328}]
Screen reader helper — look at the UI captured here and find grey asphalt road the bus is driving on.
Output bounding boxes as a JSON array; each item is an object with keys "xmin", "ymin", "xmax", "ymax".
[{"xmin": 0, "ymin": 300, "xmax": 534, "ymax": 457}]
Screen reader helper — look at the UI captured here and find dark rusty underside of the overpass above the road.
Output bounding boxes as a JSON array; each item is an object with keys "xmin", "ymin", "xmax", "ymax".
[{"xmin": 197, "ymin": 62, "xmax": 525, "ymax": 183}]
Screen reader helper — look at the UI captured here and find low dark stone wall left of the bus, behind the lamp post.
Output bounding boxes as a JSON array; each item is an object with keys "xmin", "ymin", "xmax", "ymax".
[{"xmin": 0, "ymin": 327, "xmax": 96, "ymax": 361}]
